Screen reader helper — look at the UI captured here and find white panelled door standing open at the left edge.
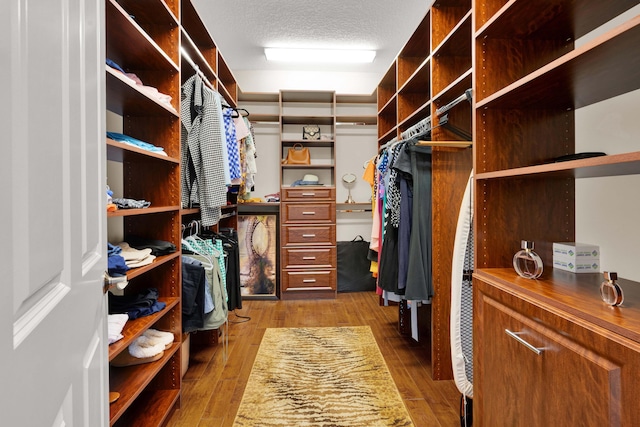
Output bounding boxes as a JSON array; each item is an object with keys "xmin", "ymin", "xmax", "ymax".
[{"xmin": 0, "ymin": 0, "xmax": 109, "ymax": 427}]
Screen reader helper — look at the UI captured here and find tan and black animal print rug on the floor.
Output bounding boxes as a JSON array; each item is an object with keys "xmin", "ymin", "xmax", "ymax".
[{"xmin": 234, "ymin": 326, "xmax": 413, "ymax": 427}]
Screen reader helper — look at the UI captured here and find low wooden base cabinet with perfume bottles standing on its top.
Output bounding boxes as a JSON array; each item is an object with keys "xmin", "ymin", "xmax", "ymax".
[{"xmin": 473, "ymin": 269, "xmax": 640, "ymax": 427}]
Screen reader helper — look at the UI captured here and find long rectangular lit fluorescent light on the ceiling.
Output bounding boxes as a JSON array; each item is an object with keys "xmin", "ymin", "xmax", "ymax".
[{"xmin": 264, "ymin": 47, "xmax": 376, "ymax": 64}]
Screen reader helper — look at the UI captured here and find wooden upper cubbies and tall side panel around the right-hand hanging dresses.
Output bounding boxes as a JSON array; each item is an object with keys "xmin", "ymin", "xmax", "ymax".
[{"xmin": 377, "ymin": 0, "xmax": 473, "ymax": 379}]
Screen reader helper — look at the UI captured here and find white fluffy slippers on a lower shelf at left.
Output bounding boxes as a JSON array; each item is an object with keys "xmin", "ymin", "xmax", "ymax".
[{"xmin": 111, "ymin": 329, "xmax": 174, "ymax": 367}]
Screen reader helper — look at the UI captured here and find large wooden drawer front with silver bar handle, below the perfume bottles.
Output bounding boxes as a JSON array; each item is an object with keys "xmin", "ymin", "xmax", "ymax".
[{"xmin": 473, "ymin": 279, "xmax": 640, "ymax": 427}]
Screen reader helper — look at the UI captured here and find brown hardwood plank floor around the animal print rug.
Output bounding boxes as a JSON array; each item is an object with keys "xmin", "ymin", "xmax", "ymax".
[{"xmin": 168, "ymin": 292, "xmax": 460, "ymax": 427}]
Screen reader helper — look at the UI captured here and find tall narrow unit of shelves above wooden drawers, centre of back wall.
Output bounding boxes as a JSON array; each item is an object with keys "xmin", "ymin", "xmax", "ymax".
[{"xmin": 279, "ymin": 91, "xmax": 337, "ymax": 299}]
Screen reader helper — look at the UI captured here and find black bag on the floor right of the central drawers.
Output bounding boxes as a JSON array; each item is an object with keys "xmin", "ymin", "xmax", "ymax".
[{"xmin": 337, "ymin": 235, "xmax": 376, "ymax": 292}]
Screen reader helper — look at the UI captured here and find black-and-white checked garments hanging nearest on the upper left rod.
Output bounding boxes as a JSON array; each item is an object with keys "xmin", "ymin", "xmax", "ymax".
[{"xmin": 180, "ymin": 74, "xmax": 227, "ymax": 226}]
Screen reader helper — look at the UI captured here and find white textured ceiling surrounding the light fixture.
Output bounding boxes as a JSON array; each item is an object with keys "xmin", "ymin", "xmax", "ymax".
[{"xmin": 192, "ymin": 0, "xmax": 431, "ymax": 91}]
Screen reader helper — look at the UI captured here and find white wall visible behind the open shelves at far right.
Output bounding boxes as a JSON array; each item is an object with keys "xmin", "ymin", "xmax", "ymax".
[{"xmin": 575, "ymin": 6, "xmax": 640, "ymax": 281}]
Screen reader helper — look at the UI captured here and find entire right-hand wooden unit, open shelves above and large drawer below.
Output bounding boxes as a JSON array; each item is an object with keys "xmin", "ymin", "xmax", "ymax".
[{"xmin": 473, "ymin": 0, "xmax": 640, "ymax": 426}]
